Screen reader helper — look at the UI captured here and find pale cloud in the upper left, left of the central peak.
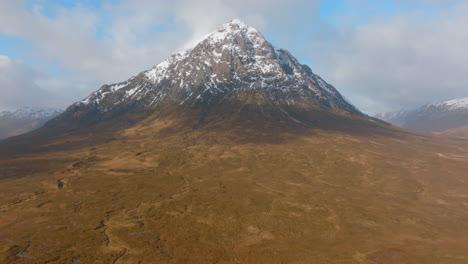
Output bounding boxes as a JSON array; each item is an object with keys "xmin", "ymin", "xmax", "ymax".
[{"xmin": 0, "ymin": 1, "xmax": 176, "ymax": 82}]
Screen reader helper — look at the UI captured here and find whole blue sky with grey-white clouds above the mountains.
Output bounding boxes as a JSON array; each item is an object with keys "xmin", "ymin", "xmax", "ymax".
[{"xmin": 0, "ymin": 0, "xmax": 468, "ymax": 115}]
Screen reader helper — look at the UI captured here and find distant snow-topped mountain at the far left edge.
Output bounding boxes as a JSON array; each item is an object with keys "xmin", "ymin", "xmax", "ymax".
[{"xmin": 0, "ymin": 107, "xmax": 63, "ymax": 139}]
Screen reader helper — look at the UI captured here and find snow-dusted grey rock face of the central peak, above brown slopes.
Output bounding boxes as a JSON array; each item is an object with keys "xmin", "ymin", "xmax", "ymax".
[{"xmin": 54, "ymin": 20, "xmax": 361, "ymax": 126}]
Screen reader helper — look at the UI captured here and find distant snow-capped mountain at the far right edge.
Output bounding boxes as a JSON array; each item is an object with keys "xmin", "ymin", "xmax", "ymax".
[{"xmin": 376, "ymin": 97, "xmax": 468, "ymax": 132}]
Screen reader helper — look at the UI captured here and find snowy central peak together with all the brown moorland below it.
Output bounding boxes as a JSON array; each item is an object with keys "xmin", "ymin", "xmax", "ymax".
[{"xmin": 0, "ymin": 20, "xmax": 468, "ymax": 264}]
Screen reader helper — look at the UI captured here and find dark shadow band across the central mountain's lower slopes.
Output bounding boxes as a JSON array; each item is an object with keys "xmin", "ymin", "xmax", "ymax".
[{"xmin": 0, "ymin": 104, "xmax": 410, "ymax": 159}]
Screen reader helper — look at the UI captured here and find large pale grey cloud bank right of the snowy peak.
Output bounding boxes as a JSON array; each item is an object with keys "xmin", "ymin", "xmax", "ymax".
[{"xmin": 310, "ymin": 1, "xmax": 468, "ymax": 113}]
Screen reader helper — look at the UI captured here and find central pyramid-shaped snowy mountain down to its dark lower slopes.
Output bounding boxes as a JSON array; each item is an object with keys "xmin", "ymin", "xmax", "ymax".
[{"xmin": 0, "ymin": 20, "xmax": 372, "ymax": 156}]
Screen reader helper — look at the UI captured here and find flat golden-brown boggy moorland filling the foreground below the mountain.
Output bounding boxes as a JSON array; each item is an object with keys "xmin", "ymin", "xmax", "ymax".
[{"xmin": 0, "ymin": 112, "xmax": 468, "ymax": 264}]
